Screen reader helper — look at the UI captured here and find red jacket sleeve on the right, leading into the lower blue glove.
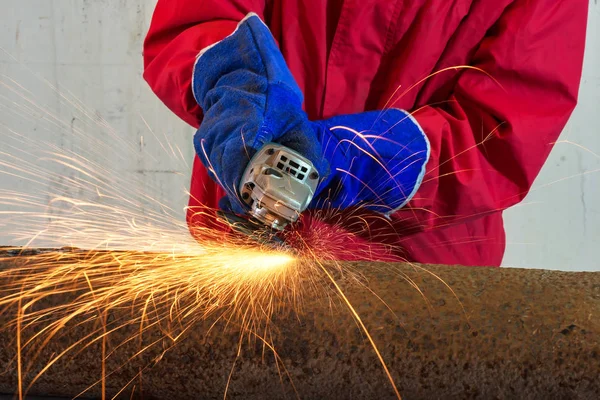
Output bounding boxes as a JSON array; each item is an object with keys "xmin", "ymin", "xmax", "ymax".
[{"xmin": 393, "ymin": 0, "xmax": 588, "ymax": 234}]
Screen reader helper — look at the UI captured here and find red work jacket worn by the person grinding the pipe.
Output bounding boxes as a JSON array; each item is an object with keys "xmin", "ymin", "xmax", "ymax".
[{"xmin": 144, "ymin": 0, "xmax": 588, "ymax": 266}]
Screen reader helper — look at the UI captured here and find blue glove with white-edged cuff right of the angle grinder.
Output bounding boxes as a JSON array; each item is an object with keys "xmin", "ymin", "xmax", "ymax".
[{"xmin": 310, "ymin": 109, "xmax": 430, "ymax": 215}]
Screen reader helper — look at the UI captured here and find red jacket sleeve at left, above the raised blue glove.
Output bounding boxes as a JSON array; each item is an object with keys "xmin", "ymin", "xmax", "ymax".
[{"xmin": 144, "ymin": 0, "xmax": 265, "ymax": 127}]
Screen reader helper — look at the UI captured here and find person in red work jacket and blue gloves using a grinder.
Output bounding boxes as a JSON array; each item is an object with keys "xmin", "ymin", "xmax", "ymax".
[{"xmin": 144, "ymin": 0, "xmax": 588, "ymax": 266}]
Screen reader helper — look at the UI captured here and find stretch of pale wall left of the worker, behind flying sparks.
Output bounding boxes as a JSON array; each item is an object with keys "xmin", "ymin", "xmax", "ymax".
[{"xmin": 0, "ymin": 0, "xmax": 194, "ymax": 250}]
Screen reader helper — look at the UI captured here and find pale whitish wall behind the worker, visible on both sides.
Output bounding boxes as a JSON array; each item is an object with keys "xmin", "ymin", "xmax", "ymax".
[{"xmin": 0, "ymin": 0, "xmax": 600, "ymax": 270}]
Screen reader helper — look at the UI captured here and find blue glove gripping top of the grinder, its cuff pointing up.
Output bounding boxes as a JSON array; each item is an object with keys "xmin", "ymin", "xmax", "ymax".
[{"xmin": 192, "ymin": 14, "xmax": 329, "ymax": 214}]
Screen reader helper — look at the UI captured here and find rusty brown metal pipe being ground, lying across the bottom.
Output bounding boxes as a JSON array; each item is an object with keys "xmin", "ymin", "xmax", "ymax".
[{"xmin": 0, "ymin": 252, "xmax": 600, "ymax": 399}]
